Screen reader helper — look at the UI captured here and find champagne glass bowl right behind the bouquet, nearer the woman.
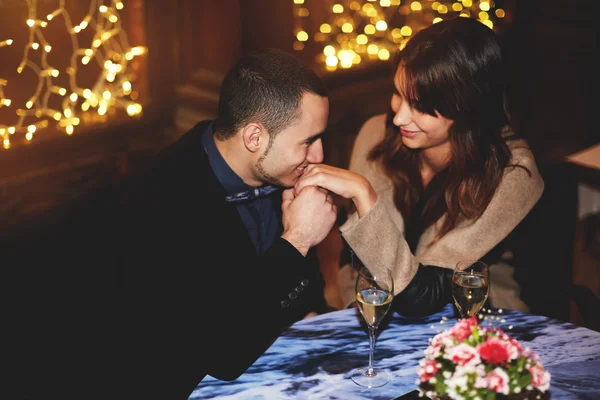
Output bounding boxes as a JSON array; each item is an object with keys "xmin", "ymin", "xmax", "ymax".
[{"xmin": 452, "ymin": 260, "xmax": 490, "ymax": 318}]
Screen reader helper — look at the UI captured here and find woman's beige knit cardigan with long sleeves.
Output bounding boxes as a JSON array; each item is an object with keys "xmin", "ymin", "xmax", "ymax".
[{"xmin": 340, "ymin": 115, "xmax": 544, "ymax": 308}]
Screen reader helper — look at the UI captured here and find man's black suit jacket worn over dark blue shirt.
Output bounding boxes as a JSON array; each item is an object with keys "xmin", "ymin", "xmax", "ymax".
[{"xmin": 114, "ymin": 121, "xmax": 326, "ymax": 400}]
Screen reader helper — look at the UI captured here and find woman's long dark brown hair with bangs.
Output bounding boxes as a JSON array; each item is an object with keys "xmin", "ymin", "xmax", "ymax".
[{"xmin": 368, "ymin": 17, "xmax": 528, "ymax": 244}]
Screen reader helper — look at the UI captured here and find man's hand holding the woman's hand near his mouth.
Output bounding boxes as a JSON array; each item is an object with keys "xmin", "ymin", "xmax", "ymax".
[{"xmin": 281, "ymin": 186, "xmax": 337, "ymax": 256}]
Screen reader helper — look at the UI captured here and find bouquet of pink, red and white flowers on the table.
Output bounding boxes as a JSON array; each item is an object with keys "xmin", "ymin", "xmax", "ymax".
[{"xmin": 418, "ymin": 316, "xmax": 550, "ymax": 400}]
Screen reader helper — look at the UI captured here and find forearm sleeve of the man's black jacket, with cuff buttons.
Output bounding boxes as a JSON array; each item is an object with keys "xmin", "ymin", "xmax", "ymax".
[{"xmin": 208, "ymin": 238, "xmax": 326, "ymax": 381}]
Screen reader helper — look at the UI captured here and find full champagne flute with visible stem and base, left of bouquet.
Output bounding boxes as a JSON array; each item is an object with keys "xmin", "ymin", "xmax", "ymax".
[{"xmin": 352, "ymin": 266, "xmax": 394, "ymax": 388}]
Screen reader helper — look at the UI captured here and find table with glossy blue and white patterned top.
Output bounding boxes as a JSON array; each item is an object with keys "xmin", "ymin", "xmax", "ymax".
[{"xmin": 189, "ymin": 304, "xmax": 600, "ymax": 400}]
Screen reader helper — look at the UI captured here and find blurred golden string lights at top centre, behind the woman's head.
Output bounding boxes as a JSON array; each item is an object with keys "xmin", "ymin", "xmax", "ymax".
[{"xmin": 292, "ymin": 0, "xmax": 505, "ymax": 71}]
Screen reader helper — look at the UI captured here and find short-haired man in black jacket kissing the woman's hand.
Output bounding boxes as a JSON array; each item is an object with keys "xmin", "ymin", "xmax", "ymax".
[{"xmin": 2, "ymin": 49, "xmax": 337, "ymax": 400}]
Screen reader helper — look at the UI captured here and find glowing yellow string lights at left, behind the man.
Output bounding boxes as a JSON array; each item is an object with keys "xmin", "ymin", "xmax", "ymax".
[{"xmin": 0, "ymin": 0, "xmax": 146, "ymax": 149}]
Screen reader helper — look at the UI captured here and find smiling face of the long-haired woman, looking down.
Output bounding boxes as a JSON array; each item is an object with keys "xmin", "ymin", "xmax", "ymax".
[{"xmin": 391, "ymin": 66, "xmax": 454, "ymax": 152}]
